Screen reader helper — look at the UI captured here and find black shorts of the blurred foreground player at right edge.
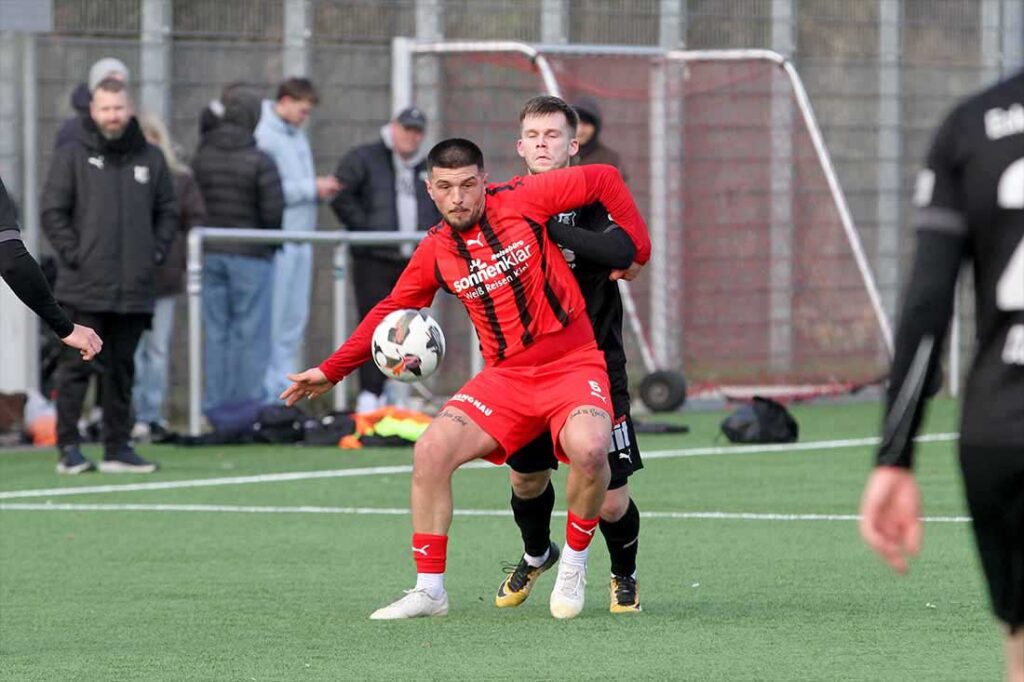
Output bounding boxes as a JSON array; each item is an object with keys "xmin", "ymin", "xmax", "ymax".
[{"xmin": 961, "ymin": 444, "xmax": 1024, "ymax": 632}]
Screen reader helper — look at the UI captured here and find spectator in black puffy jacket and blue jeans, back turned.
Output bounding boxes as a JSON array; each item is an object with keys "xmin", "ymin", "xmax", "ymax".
[{"xmin": 193, "ymin": 88, "xmax": 285, "ymax": 411}]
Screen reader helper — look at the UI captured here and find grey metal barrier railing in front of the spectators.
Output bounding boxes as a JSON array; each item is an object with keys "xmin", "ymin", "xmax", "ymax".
[{"xmin": 187, "ymin": 227, "xmax": 425, "ymax": 435}]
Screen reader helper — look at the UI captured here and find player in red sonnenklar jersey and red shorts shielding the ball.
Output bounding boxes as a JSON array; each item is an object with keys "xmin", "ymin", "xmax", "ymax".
[{"xmin": 281, "ymin": 138, "xmax": 650, "ymax": 620}]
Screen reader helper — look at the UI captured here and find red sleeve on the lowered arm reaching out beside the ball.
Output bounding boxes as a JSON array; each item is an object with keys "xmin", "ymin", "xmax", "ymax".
[{"xmin": 319, "ymin": 236, "xmax": 440, "ymax": 384}]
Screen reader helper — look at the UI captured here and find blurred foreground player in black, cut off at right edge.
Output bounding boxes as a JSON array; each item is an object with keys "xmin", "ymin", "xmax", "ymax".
[{"xmin": 860, "ymin": 72, "xmax": 1024, "ymax": 682}]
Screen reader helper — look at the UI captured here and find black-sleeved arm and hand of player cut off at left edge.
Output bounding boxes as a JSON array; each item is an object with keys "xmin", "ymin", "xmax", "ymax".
[{"xmin": 0, "ymin": 173, "xmax": 103, "ymax": 368}]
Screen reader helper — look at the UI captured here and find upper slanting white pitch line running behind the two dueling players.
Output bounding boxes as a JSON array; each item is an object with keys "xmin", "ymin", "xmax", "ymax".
[{"xmin": 0, "ymin": 433, "xmax": 957, "ymax": 500}]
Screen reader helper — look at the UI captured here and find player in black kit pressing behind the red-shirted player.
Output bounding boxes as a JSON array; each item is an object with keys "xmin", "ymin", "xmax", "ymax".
[{"xmin": 495, "ymin": 96, "xmax": 643, "ymax": 613}]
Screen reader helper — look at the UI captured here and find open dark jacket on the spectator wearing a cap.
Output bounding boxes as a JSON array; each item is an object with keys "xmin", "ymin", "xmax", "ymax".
[{"xmin": 331, "ymin": 140, "xmax": 441, "ymax": 261}]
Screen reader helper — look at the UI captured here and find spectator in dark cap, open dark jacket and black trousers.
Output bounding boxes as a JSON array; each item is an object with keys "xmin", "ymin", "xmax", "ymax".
[{"xmin": 331, "ymin": 106, "xmax": 440, "ymax": 412}]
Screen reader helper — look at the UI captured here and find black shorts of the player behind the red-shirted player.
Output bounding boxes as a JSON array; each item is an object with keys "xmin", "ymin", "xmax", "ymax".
[{"xmin": 505, "ymin": 377, "xmax": 643, "ymax": 491}]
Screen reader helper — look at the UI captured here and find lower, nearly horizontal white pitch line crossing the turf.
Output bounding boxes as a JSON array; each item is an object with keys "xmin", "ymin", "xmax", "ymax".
[{"xmin": 0, "ymin": 502, "xmax": 971, "ymax": 523}]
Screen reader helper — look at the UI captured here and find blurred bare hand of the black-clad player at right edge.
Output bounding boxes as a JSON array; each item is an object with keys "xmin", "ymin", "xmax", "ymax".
[{"xmin": 860, "ymin": 467, "xmax": 922, "ymax": 573}]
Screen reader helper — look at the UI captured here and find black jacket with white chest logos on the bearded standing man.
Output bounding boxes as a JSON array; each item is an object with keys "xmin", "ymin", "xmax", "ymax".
[{"xmin": 40, "ymin": 118, "xmax": 178, "ymax": 313}]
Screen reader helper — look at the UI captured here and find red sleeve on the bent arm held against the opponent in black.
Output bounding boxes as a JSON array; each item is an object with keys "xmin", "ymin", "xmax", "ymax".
[{"xmin": 510, "ymin": 164, "xmax": 650, "ymax": 264}]
